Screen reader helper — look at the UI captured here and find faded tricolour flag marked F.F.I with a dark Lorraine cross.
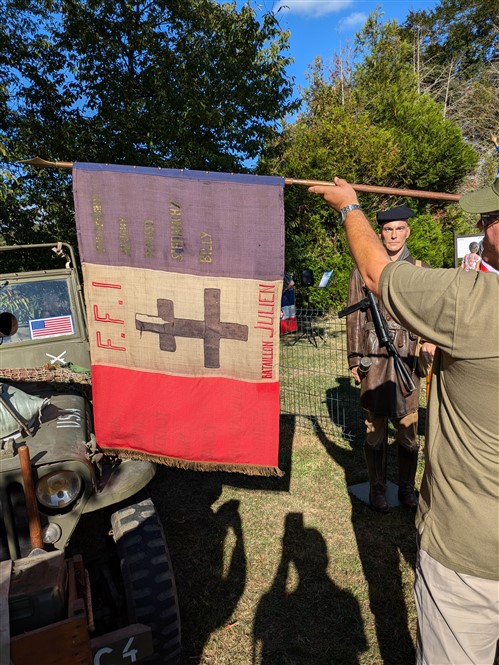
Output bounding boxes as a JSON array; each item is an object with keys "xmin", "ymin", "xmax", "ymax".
[{"xmin": 73, "ymin": 163, "xmax": 284, "ymax": 474}]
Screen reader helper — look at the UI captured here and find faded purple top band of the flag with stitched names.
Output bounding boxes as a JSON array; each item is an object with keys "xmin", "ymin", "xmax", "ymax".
[{"xmin": 73, "ymin": 164, "xmax": 284, "ymax": 281}]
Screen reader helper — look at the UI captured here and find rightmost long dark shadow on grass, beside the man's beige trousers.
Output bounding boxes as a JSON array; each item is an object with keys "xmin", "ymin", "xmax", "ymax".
[{"xmin": 316, "ymin": 424, "xmax": 416, "ymax": 665}]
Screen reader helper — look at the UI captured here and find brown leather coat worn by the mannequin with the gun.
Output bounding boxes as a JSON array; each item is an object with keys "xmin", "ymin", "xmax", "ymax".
[{"xmin": 347, "ymin": 256, "xmax": 429, "ymax": 418}]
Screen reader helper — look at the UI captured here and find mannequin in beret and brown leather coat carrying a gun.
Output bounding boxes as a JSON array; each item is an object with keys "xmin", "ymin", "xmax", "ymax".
[{"xmin": 347, "ymin": 206, "xmax": 435, "ymax": 513}]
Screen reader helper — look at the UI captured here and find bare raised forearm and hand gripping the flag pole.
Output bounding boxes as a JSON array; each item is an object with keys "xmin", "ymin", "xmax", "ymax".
[{"xmin": 308, "ymin": 178, "xmax": 390, "ymax": 296}]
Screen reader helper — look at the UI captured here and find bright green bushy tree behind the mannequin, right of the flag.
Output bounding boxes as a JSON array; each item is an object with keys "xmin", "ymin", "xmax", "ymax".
[{"xmin": 259, "ymin": 12, "xmax": 477, "ymax": 307}]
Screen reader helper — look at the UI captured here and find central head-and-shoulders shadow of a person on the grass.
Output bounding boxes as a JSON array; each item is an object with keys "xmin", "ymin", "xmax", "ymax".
[{"xmin": 253, "ymin": 513, "xmax": 367, "ymax": 665}]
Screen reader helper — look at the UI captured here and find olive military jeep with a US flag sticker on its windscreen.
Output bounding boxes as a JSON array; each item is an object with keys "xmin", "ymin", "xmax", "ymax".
[{"xmin": 0, "ymin": 243, "xmax": 180, "ymax": 665}]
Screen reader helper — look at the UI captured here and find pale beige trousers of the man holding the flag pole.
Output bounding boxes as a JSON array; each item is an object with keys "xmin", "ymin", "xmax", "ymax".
[{"xmin": 414, "ymin": 549, "xmax": 499, "ymax": 665}]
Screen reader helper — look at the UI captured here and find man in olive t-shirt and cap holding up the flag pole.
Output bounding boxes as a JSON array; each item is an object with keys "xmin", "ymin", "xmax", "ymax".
[{"xmin": 309, "ymin": 178, "xmax": 499, "ymax": 665}]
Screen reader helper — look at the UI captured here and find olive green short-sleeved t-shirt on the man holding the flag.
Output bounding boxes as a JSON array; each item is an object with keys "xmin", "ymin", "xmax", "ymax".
[{"xmin": 380, "ymin": 262, "xmax": 499, "ymax": 579}]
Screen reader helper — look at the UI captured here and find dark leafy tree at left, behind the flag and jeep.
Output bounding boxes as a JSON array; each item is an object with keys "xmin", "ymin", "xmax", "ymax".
[{"xmin": 0, "ymin": 0, "xmax": 296, "ymax": 242}]
